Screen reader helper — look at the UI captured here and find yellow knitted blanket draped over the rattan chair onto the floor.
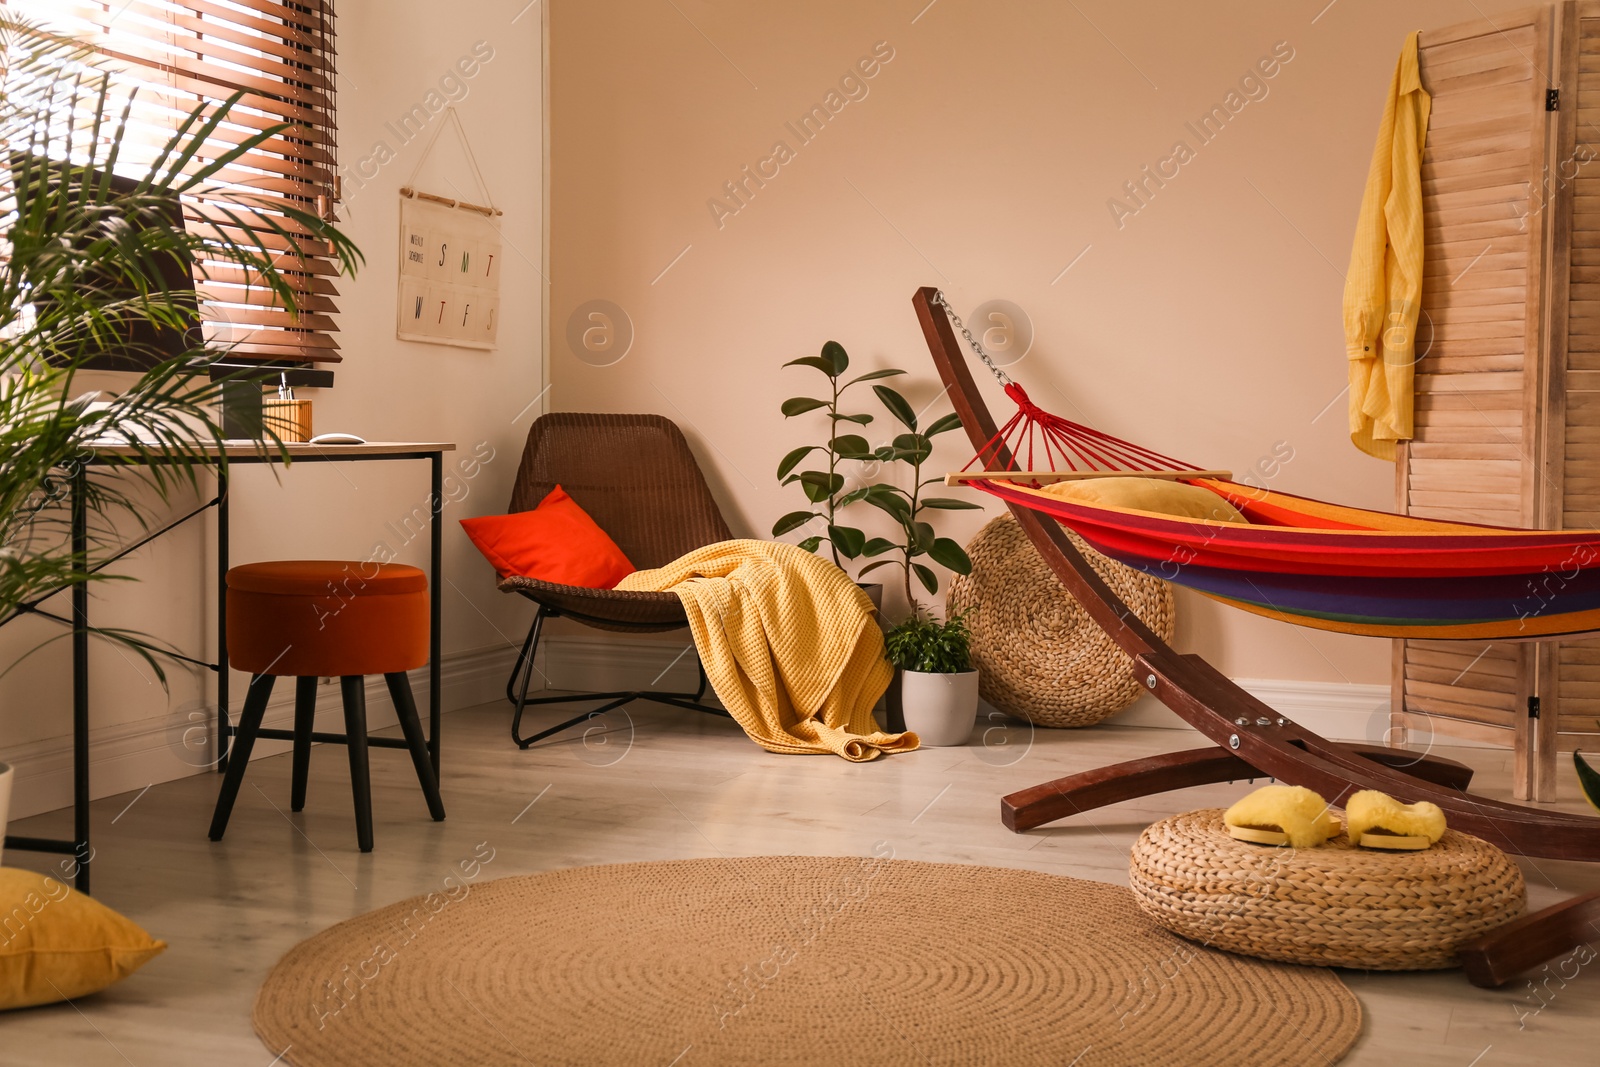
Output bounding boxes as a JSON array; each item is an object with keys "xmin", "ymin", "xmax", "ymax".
[{"xmin": 618, "ymin": 541, "xmax": 917, "ymax": 761}]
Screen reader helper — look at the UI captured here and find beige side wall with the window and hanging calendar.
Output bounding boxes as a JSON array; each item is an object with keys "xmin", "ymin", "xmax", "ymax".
[{"xmin": 0, "ymin": 0, "xmax": 544, "ymax": 817}]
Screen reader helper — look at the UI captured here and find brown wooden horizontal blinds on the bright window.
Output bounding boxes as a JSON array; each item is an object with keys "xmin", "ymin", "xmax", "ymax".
[{"xmin": 3, "ymin": 0, "xmax": 339, "ymax": 363}]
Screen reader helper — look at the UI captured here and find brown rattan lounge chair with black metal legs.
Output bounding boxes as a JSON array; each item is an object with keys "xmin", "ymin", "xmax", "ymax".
[{"xmin": 499, "ymin": 411, "xmax": 733, "ymax": 749}]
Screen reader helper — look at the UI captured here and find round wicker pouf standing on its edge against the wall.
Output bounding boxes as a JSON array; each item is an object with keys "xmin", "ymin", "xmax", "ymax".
[{"xmin": 947, "ymin": 515, "xmax": 1174, "ymax": 726}]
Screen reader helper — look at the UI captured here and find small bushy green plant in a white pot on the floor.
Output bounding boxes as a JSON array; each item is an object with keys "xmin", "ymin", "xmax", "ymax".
[{"xmin": 883, "ymin": 609, "xmax": 978, "ymax": 747}]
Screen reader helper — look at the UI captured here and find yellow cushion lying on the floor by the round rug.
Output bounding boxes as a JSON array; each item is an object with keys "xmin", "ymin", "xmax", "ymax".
[{"xmin": 0, "ymin": 867, "xmax": 166, "ymax": 1011}]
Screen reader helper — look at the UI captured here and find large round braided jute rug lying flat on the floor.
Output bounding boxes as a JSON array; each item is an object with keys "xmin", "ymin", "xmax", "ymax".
[{"xmin": 254, "ymin": 849, "xmax": 1362, "ymax": 1067}]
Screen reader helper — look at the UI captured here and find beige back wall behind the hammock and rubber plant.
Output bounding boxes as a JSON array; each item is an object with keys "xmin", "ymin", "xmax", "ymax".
[{"xmin": 550, "ymin": 0, "xmax": 1520, "ymax": 683}]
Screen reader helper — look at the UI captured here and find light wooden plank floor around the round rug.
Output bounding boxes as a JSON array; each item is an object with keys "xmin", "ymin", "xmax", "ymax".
[{"xmin": 0, "ymin": 705, "xmax": 1600, "ymax": 1067}]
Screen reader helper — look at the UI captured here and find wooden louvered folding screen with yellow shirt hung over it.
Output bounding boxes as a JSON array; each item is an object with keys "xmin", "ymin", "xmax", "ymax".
[{"xmin": 1394, "ymin": 0, "xmax": 1600, "ymax": 800}]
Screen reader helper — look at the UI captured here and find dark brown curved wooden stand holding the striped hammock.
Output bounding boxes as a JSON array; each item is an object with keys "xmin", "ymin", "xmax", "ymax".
[{"xmin": 912, "ymin": 286, "xmax": 1600, "ymax": 987}]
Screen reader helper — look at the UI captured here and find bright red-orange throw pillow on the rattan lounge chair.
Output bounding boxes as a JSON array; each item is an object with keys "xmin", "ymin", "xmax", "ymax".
[{"xmin": 461, "ymin": 486, "xmax": 638, "ymax": 589}]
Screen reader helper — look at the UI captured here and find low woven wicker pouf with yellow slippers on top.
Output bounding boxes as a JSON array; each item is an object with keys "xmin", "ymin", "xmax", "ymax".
[{"xmin": 1128, "ymin": 808, "xmax": 1523, "ymax": 971}]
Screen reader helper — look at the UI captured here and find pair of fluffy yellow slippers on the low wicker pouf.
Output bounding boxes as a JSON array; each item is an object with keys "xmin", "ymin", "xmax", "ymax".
[{"xmin": 1222, "ymin": 785, "xmax": 1445, "ymax": 851}]
